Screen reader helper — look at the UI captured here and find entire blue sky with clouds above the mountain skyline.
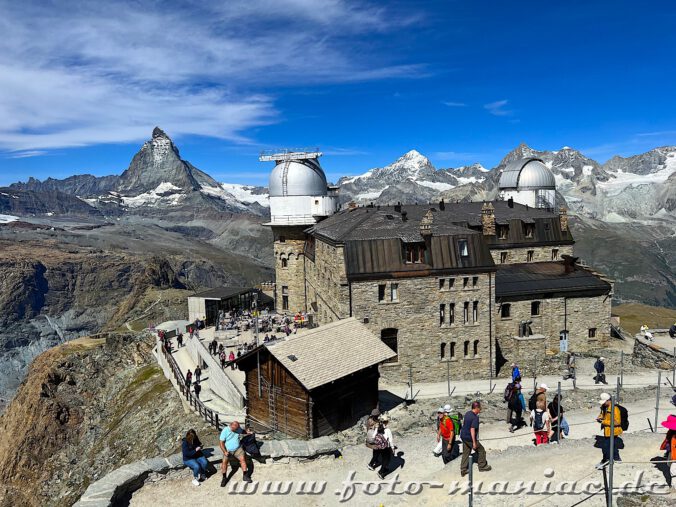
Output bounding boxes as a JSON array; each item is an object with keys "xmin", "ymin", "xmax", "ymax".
[{"xmin": 0, "ymin": 0, "xmax": 676, "ymax": 185}]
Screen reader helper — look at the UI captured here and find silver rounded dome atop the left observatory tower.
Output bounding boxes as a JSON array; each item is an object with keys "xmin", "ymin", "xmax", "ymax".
[{"xmin": 268, "ymin": 159, "xmax": 327, "ymax": 197}]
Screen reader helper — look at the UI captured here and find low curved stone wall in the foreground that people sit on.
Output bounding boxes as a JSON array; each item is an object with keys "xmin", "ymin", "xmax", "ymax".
[{"xmin": 75, "ymin": 437, "xmax": 338, "ymax": 507}]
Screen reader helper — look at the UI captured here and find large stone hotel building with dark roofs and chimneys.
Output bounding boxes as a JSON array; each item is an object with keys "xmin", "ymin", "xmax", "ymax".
[{"xmin": 264, "ymin": 155, "xmax": 612, "ymax": 381}]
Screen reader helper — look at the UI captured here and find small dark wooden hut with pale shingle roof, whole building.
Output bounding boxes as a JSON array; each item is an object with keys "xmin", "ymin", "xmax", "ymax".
[{"xmin": 238, "ymin": 318, "xmax": 396, "ymax": 438}]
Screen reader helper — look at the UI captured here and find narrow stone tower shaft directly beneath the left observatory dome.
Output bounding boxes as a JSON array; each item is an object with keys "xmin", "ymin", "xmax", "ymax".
[{"xmin": 272, "ymin": 226, "xmax": 306, "ymax": 313}]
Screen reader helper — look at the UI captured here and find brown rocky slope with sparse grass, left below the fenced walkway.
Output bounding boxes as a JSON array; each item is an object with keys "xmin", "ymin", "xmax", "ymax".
[{"xmin": 0, "ymin": 334, "xmax": 217, "ymax": 507}]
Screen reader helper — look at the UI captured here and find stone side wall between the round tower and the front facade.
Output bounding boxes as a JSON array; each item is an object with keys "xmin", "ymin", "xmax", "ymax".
[{"xmin": 305, "ymin": 239, "xmax": 350, "ymax": 324}]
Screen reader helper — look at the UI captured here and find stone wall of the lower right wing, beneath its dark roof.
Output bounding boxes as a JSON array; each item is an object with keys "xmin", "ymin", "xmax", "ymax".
[{"xmin": 494, "ymin": 296, "xmax": 610, "ymax": 375}]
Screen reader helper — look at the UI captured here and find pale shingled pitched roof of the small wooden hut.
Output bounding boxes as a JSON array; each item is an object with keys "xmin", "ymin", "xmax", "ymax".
[{"xmin": 267, "ymin": 317, "xmax": 396, "ymax": 390}]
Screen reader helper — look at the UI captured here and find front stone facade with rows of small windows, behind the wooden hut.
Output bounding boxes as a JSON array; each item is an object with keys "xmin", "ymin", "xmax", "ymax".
[{"xmin": 352, "ymin": 273, "xmax": 495, "ymax": 382}]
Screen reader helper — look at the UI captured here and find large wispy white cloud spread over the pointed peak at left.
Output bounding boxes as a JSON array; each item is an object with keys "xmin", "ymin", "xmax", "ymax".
[{"xmin": 0, "ymin": 0, "xmax": 424, "ymax": 152}]
